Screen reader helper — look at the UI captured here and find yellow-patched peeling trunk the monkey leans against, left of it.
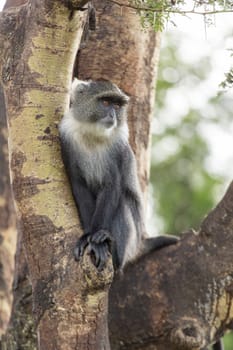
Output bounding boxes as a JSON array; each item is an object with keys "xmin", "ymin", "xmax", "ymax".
[{"xmin": 0, "ymin": 0, "xmax": 113, "ymax": 350}]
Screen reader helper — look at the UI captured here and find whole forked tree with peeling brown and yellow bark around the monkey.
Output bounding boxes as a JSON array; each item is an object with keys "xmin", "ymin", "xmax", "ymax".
[{"xmin": 0, "ymin": 0, "xmax": 233, "ymax": 350}]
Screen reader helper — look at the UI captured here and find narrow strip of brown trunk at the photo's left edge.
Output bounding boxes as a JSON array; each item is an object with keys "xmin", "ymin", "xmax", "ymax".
[{"xmin": 0, "ymin": 84, "xmax": 16, "ymax": 337}]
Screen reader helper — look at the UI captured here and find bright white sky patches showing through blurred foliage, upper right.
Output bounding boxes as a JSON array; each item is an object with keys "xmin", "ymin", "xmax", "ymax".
[{"xmin": 0, "ymin": 0, "xmax": 233, "ymax": 179}]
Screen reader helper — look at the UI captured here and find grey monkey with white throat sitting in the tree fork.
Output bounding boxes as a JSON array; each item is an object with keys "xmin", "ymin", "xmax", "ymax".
[{"xmin": 59, "ymin": 79, "xmax": 178, "ymax": 271}]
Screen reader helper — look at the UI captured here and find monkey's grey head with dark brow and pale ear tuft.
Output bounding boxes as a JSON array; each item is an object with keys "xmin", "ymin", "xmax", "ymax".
[{"xmin": 71, "ymin": 79, "xmax": 129, "ymax": 130}]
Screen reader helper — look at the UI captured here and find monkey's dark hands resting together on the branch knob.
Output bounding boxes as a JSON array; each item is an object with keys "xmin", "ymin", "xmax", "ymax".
[{"xmin": 74, "ymin": 230, "xmax": 112, "ymax": 271}]
